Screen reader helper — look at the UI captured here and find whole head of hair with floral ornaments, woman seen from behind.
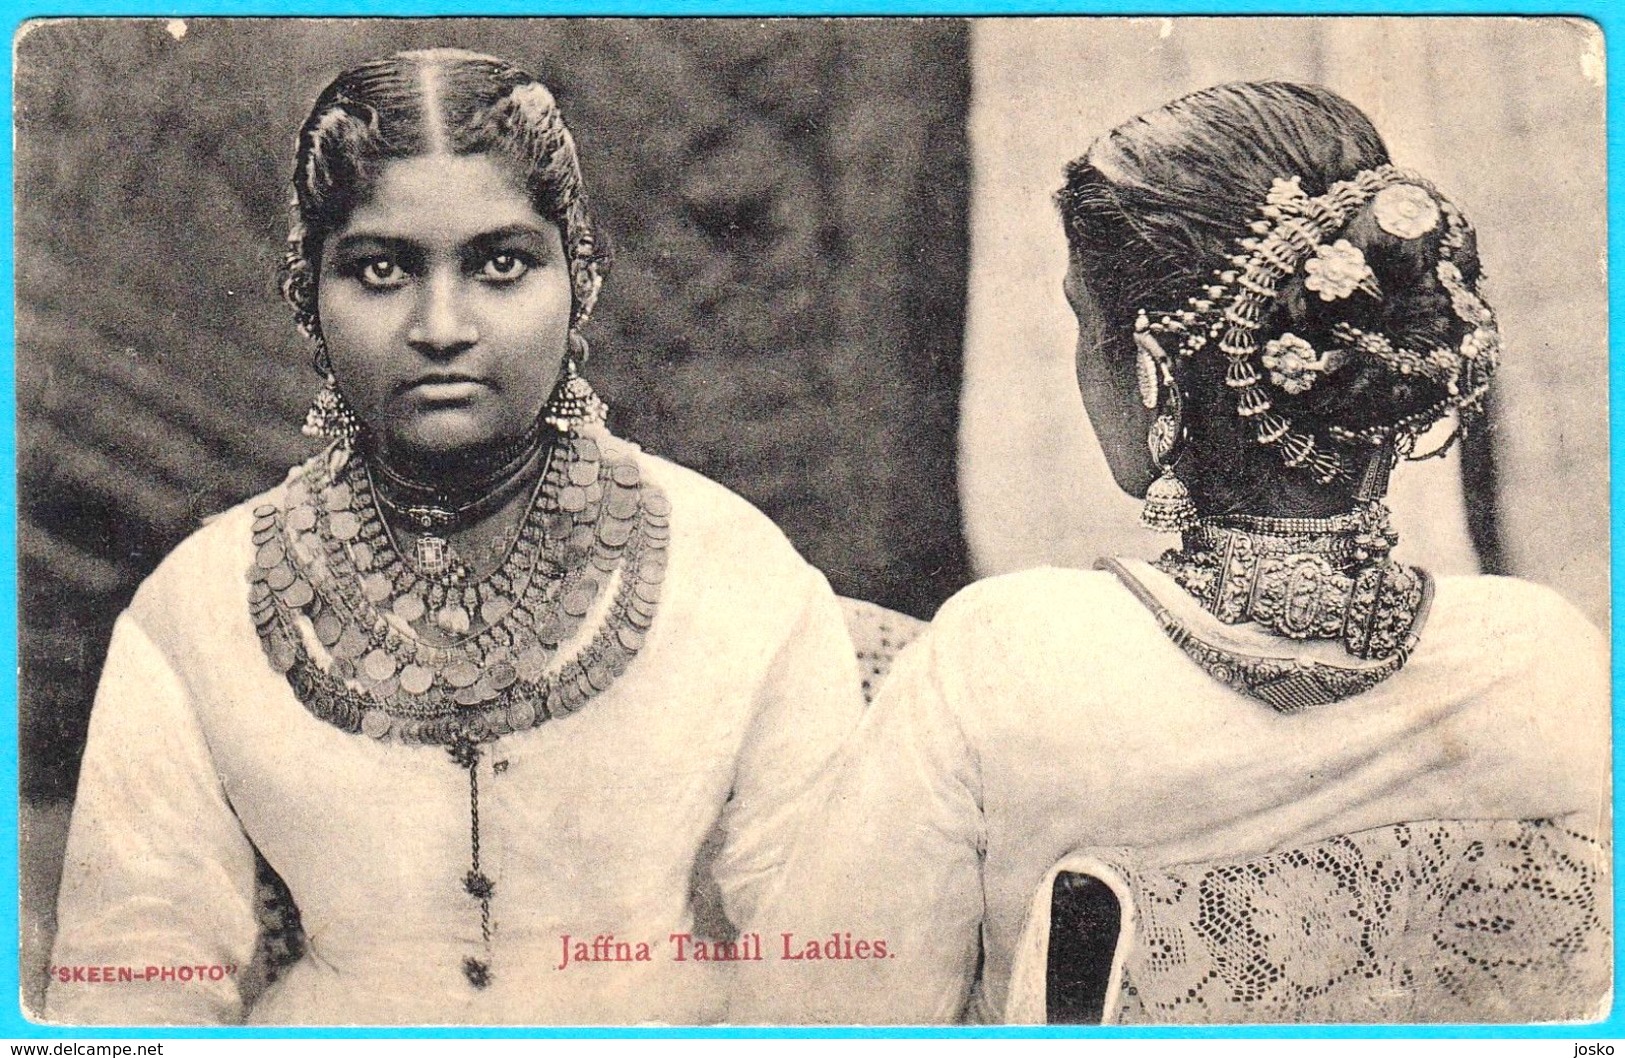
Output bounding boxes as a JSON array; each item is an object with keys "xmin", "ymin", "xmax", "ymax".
[{"xmin": 1058, "ymin": 81, "xmax": 1498, "ymax": 484}]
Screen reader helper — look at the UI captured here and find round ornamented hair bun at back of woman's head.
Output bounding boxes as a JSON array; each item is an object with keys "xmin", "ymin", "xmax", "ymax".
[{"xmin": 1152, "ymin": 166, "xmax": 1497, "ymax": 481}]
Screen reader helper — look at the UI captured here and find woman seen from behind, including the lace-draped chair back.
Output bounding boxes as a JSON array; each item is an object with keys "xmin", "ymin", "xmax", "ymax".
[{"xmin": 733, "ymin": 85, "xmax": 1610, "ymax": 1022}]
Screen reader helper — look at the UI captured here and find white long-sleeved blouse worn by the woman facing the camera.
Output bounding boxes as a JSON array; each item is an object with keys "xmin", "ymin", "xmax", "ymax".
[{"xmin": 47, "ymin": 453, "xmax": 863, "ymax": 1025}]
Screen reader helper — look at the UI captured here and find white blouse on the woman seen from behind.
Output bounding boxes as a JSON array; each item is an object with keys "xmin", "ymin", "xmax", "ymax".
[{"xmin": 730, "ymin": 564, "xmax": 1610, "ymax": 1024}]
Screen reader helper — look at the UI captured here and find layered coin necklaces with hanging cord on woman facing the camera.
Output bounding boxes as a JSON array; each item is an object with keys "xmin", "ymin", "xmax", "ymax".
[{"xmin": 249, "ymin": 432, "xmax": 671, "ymax": 988}]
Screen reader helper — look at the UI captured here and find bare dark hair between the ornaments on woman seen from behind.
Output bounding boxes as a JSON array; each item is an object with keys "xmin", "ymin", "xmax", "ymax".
[{"xmin": 1056, "ymin": 83, "xmax": 1480, "ymax": 461}]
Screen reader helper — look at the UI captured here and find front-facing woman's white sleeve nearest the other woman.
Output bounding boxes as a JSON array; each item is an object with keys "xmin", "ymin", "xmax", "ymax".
[{"xmin": 712, "ymin": 567, "xmax": 863, "ymax": 923}]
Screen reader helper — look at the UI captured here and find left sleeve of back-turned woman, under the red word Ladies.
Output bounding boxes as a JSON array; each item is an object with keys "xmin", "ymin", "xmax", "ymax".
[{"xmin": 730, "ymin": 620, "xmax": 985, "ymax": 1025}]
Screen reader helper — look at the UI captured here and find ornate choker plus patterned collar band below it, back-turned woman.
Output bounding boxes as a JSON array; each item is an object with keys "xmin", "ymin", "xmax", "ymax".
[{"xmin": 1103, "ymin": 501, "xmax": 1433, "ymax": 712}]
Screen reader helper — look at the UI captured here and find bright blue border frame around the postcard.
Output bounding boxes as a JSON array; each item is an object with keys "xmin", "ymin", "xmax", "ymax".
[{"xmin": 0, "ymin": 0, "xmax": 1625, "ymax": 1040}]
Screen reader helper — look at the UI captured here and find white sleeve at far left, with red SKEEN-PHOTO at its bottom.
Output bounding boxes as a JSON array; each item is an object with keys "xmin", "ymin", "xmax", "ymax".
[{"xmin": 46, "ymin": 613, "xmax": 257, "ymax": 1024}]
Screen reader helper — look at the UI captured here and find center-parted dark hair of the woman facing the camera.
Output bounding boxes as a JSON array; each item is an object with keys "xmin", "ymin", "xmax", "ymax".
[{"xmin": 281, "ymin": 49, "xmax": 609, "ymax": 338}]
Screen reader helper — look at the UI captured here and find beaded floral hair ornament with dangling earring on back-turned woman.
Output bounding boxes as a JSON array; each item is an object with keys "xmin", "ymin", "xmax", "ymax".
[{"xmin": 1134, "ymin": 166, "xmax": 1500, "ymax": 531}]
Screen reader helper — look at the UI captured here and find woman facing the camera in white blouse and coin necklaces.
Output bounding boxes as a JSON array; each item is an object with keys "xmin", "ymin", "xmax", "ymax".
[{"xmin": 47, "ymin": 50, "xmax": 861, "ymax": 1024}]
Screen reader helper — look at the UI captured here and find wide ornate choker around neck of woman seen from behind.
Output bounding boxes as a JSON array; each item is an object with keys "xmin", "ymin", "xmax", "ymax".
[{"xmin": 1155, "ymin": 501, "xmax": 1430, "ymax": 663}]
